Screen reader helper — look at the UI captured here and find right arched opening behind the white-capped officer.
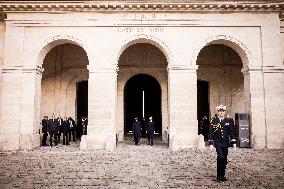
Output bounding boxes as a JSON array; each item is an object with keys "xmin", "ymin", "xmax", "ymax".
[{"xmin": 197, "ymin": 44, "xmax": 246, "ymax": 139}]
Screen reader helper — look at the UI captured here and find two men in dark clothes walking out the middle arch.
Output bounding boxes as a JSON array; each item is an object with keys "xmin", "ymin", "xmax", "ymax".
[{"xmin": 132, "ymin": 116, "xmax": 155, "ymax": 146}]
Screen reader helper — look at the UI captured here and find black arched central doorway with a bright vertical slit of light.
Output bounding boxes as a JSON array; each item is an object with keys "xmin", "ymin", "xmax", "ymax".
[{"xmin": 124, "ymin": 74, "xmax": 162, "ymax": 135}]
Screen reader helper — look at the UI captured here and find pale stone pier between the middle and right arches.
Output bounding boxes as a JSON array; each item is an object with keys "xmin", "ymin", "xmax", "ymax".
[{"xmin": 168, "ymin": 65, "xmax": 204, "ymax": 150}]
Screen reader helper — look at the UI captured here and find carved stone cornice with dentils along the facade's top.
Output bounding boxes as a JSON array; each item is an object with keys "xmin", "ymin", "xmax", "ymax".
[{"xmin": 0, "ymin": 1, "xmax": 284, "ymax": 13}]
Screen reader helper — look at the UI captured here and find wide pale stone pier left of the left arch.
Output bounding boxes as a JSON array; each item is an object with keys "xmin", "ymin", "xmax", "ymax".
[{"xmin": 0, "ymin": 66, "xmax": 42, "ymax": 150}]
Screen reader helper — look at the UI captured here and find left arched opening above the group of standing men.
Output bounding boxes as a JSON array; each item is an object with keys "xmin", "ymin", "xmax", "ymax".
[{"xmin": 40, "ymin": 41, "xmax": 89, "ymax": 145}]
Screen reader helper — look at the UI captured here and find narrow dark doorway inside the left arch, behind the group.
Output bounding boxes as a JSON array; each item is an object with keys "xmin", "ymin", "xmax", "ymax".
[{"xmin": 76, "ymin": 81, "xmax": 88, "ymax": 119}]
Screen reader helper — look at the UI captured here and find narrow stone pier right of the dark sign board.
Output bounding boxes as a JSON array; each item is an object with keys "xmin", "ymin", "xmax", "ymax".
[{"xmin": 242, "ymin": 67, "xmax": 267, "ymax": 148}]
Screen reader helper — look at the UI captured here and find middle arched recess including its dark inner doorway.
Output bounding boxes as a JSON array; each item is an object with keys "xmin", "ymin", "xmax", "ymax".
[{"xmin": 116, "ymin": 39, "xmax": 168, "ymax": 142}]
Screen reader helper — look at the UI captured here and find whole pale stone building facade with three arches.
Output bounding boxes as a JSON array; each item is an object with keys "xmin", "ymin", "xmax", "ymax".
[{"xmin": 0, "ymin": 0, "xmax": 284, "ymax": 151}]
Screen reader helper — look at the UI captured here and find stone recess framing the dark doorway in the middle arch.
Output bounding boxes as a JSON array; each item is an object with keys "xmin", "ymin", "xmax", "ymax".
[{"xmin": 116, "ymin": 39, "xmax": 168, "ymax": 141}]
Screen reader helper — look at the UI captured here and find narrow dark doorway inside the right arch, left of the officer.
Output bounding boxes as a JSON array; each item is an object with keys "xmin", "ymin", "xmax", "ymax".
[{"xmin": 197, "ymin": 80, "xmax": 209, "ymax": 120}]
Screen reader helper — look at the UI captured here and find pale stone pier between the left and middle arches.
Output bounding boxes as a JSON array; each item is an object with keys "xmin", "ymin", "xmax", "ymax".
[{"xmin": 80, "ymin": 66, "xmax": 117, "ymax": 150}]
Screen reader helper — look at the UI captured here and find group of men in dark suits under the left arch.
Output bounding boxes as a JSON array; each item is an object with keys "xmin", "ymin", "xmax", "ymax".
[{"xmin": 41, "ymin": 114, "xmax": 88, "ymax": 146}]
